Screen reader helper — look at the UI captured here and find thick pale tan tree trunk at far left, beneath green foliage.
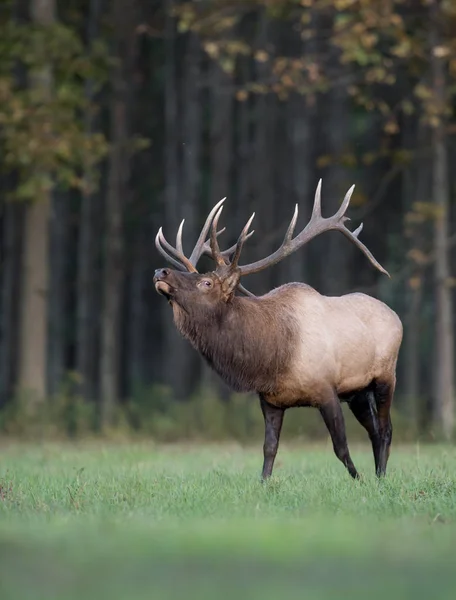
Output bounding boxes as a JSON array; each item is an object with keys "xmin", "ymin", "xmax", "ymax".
[{"xmin": 18, "ymin": 0, "xmax": 55, "ymax": 401}]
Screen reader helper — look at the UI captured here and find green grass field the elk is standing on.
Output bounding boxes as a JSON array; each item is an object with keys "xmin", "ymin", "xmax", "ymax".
[{"xmin": 0, "ymin": 443, "xmax": 456, "ymax": 600}]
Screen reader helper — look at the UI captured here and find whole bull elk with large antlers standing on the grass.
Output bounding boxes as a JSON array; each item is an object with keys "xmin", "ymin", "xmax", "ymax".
[{"xmin": 154, "ymin": 180, "xmax": 403, "ymax": 480}]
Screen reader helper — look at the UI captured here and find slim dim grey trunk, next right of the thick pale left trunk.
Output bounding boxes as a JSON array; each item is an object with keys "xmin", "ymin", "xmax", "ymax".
[{"xmin": 76, "ymin": 0, "xmax": 101, "ymax": 408}]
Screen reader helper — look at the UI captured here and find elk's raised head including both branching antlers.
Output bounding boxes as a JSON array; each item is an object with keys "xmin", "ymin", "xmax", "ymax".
[{"xmin": 154, "ymin": 180, "xmax": 389, "ymax": 313}]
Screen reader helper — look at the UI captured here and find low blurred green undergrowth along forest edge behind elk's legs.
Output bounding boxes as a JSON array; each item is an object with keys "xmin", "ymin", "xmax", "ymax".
[{"xmin": 0, "ymin": 376, "xmax": 415, "ymax": 447}]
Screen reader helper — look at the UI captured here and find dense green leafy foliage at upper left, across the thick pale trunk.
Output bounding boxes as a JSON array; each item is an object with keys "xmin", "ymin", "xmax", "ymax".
[{"xmin": 0, "ymin": 22, "xmax": 108, "ymax": 200}]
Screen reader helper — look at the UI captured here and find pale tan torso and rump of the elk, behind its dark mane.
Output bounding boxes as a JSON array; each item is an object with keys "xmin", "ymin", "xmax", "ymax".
[{"xmin": 260, "ymin": 283, "xmax": 402, "ymax": 407}]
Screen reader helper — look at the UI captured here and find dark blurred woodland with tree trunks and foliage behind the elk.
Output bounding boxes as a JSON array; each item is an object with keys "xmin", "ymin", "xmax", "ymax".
[{"xmin": 0, "ymin": 0, "xmax": 456, "ymax": 439}]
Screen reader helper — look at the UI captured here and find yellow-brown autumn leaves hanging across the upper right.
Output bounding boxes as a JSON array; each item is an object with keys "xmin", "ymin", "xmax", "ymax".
[{"xmin": 176, "ymin": 0, "xmax": 456, "ymax": 135}]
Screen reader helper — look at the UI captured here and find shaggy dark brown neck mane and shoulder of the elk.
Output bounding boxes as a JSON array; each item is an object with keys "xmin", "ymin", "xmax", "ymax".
[{"xmin": 173, "ymin": 297, "xmax": 295, "ymax": 393}]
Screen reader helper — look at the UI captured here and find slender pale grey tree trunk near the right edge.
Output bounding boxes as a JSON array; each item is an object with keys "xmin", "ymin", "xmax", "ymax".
[{"xmin": 431, "ymin": 0, "xmax": 454, "ymax": 440}]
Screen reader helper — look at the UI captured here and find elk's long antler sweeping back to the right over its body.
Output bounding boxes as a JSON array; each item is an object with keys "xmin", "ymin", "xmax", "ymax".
[{"xmin": 231, "ymin": 179, "xmax": 390, "ymax": 277}]
